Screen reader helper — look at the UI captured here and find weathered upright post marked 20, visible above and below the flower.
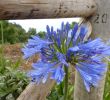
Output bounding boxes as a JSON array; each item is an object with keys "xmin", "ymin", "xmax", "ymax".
[{"xmin": 74, "ymin": 0, "xmax": 110, "ymax": 100}]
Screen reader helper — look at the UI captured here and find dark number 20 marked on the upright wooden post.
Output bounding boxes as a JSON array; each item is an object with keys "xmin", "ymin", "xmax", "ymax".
[{"xmin": 94, "ymin": 13, "xmax": 107, "ymax": 24}]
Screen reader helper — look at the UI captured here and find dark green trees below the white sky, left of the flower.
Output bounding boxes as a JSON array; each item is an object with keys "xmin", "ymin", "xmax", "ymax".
[{"xmin": 0, "ymin": 20, "xmax": 44, "ymax": 44}]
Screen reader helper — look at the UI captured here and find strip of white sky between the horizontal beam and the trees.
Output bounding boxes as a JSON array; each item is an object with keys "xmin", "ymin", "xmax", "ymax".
[{"xmin": 9, "ymin": 18, "xmax": 80, "ymax": 32}]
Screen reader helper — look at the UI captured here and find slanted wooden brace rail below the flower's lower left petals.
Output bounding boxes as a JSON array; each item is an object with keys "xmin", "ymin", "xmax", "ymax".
[{"xmin": 17, "ymin": 80, "xmax": 55, "ymax": 100}]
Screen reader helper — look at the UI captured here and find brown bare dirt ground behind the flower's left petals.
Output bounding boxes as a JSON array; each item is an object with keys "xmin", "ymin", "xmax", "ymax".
[{"xmin": 4, "ymin": 44, "xmax": 39, "ymax": 70}]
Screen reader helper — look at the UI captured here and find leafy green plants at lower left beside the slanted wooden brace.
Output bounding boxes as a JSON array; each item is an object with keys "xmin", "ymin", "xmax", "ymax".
[{"xmin": 0, "ymin": 48, "xmax": 29, "ymax": 100}]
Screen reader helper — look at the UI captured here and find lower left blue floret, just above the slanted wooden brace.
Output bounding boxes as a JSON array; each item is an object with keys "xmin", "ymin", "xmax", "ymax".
[{"xmin": 28, "ymin": 61, "xmax": 56, "ymax": 84}]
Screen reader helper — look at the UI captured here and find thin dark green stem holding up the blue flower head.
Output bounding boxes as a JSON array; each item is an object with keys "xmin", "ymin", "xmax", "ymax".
[{"xmin": 64, "ymin": 66, "xmax": 68, "ymax": 100}]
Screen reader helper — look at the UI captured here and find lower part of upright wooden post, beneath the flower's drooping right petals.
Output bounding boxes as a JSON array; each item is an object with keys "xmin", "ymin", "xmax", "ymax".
[{"xmin": 74, "ymin": 72, "xmax": 105, "ymax": 100}]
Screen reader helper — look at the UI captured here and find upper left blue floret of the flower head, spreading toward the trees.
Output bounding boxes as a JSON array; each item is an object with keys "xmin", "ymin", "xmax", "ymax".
[{"xmin": 22, "ymin": 36, "xmax": 53, "ymax": 59}]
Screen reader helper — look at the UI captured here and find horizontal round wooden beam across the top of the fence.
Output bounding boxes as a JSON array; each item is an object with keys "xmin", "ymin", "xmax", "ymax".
[{"xmin": 0, "ymin": 0, "xmax": 97, "ymax": 19}]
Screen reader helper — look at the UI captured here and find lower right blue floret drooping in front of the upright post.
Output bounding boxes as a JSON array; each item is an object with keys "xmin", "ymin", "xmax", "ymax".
[{"xmin": 76, "ymin": 62, "xmax": 106, "ymax": 92}]
